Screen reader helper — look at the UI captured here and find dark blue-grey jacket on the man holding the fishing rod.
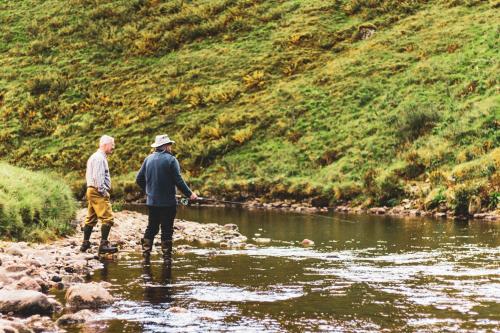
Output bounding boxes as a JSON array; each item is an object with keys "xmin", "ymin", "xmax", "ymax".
[{"xmin": 136, "ymin": 151, "xmax": 193, "ymax": 207}]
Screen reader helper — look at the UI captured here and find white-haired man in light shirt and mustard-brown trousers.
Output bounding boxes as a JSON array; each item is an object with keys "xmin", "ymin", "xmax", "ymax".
[{"xmin": 80, "ymin": 135, "xmax": 118, "ymax": 254}]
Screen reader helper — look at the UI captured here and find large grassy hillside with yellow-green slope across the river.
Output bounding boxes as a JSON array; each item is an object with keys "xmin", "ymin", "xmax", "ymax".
[{"xmin": 0, "ymin": 0, "xmax": 500, "ymax": 209}]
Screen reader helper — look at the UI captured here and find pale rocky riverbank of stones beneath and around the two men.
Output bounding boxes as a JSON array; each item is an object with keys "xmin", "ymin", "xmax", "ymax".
[{"xmin": 0, "ymin": 210, "xmax": 252, "ymax": 333}]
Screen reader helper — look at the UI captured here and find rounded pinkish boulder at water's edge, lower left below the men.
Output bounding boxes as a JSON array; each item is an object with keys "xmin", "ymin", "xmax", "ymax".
[{"xmin": 65, "ymin": 282, "xmax": 114, "ymax": 309}]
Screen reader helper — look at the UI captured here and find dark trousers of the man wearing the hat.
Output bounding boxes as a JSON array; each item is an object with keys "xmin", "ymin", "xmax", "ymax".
[{"xmin": 144, "ymin": 206, "xmax": 177, "ymax": 242}]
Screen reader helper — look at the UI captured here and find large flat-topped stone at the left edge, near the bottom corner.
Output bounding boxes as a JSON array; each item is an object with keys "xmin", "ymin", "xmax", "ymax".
[{"xmin": 0, "ymin": 290, "xmax": 55, "ymax": 315}]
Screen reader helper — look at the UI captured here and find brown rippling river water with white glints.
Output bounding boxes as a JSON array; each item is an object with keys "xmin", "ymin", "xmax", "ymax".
[{"xmin": 68, "ymin": 207, "xmax": 500, "ymax": 333}]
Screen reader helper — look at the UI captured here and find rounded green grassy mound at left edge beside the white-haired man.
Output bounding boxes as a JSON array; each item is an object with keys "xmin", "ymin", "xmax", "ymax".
[{"xmin": 0, "ymin": 162, "xmax": 76, "ymax": 241}]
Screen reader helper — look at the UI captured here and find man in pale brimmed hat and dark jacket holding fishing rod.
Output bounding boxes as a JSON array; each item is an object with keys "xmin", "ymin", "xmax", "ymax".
[{"xmin": 136, "ymin": 134, "xmax": 198, "ymax": 265}]
